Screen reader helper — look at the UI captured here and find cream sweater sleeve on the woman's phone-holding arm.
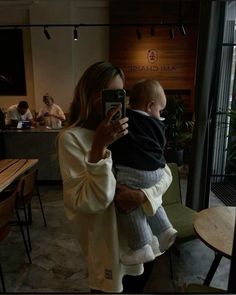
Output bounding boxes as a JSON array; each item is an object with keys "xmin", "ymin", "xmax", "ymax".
[{"xmin": 58, "ymin": 132, "xmax": 116, "ymax": 219}]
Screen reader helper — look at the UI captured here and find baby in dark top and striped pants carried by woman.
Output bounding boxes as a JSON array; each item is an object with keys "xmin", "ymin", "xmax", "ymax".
[{"xmin": 109, "ymin": 80, "xmax": 177, "ymax": 265}]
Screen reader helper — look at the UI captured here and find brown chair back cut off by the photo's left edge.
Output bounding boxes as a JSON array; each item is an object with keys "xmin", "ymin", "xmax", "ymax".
[{"xmin": 0, "ymin": 189, "xmax": 17, "ymax": 241}]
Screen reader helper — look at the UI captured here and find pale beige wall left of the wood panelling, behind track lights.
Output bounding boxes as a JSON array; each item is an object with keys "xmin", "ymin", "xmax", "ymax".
[{"xmin": 0, "ymin": 0, "xmax": 109, "ymax": 112}]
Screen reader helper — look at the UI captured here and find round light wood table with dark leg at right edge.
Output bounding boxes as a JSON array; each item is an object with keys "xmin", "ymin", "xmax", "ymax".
[{"xmin": 194, "ymin": 206, "xmax": 236, "ymax": 285}]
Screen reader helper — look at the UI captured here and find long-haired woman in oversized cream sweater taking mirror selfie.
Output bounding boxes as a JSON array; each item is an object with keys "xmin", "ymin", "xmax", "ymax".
[{"xmin": 58, "ymin": 62, "xmax": 172, "ymax": 293}]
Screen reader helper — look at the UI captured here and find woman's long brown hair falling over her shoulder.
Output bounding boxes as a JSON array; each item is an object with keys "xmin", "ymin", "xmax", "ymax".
[{"xmin": 66, "ymin": 62, "xmax": 124, "ymax": 128}]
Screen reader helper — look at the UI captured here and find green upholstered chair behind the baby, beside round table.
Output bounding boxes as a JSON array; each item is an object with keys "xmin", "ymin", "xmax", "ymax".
[{"xmin": 163, "ymin": 163, "xmax": 196, "ymax": 278}]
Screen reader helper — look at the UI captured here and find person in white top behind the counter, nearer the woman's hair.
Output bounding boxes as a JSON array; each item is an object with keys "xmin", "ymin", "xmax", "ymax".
[{"xmin": 37, "ymin": 93, "xmax": 66, "ymax": 128}]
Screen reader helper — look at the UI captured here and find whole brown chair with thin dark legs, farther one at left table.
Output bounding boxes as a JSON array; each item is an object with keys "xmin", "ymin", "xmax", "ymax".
[{"xmin": 16, "ymin": 169, "xmax": 47, "ymax": 251}]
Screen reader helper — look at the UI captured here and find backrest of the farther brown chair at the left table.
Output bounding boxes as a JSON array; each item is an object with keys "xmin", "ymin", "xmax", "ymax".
[{"xmin": 16, "ymin": 169, "xmax": 38, "ymax": 207}]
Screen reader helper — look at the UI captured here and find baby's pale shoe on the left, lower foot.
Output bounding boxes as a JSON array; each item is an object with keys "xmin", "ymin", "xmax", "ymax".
[{"xmin": 121, "ymin": 244, "xmax": 155, "ymax": 265}]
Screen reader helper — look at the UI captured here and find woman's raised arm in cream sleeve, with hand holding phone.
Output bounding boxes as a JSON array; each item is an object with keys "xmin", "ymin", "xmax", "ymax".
[{"xmin": 58, "ymin": 110, "xmax": 128, "ymax": 219}]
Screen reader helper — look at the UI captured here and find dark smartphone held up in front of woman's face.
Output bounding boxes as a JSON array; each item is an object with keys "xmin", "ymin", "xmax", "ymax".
[{"xmin": 102, "ymin": 89, "xmax": 126, "ymax": 120}]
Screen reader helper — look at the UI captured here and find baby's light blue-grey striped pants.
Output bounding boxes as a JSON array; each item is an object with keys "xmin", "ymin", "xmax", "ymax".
[{"xmin": 116, "ymin": 166, "xmax": 172, "ymax": 250}]
